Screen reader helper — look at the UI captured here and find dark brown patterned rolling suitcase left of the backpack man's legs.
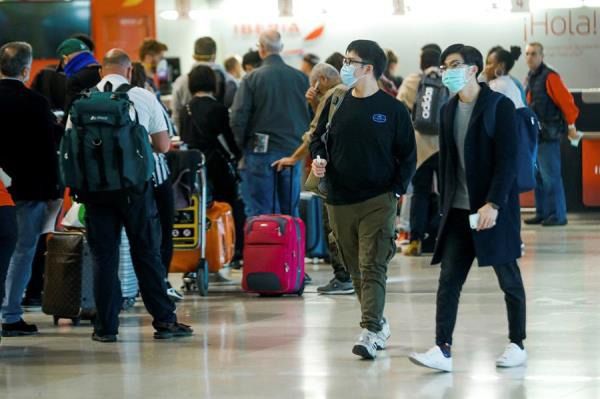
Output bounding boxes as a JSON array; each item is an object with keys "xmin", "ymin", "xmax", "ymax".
[{"xmin": 42, "ymin": 232, "xmax": 96, "ymax": 325}]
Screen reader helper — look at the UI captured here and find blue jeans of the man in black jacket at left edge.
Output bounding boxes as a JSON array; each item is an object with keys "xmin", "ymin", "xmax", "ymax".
[{"xmin": 2, "ymin": 201, "xmax": 47, "ymax": 324}]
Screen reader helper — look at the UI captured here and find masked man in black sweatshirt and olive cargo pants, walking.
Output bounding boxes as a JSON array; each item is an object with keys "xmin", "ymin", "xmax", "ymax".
[{"xmin": 310, "ymin": 40, "xmax": 416, "ymax": 359}]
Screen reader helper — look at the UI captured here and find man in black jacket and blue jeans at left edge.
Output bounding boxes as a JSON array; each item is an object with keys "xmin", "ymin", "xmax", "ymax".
[{"xmin": 0, "ymin": 42, "xmax": 60, "ymax": 337}]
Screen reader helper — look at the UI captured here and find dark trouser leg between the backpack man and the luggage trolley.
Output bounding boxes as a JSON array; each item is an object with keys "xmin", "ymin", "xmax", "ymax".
[{"xmin": 154, "ymin": 178, "xmax": 175, "ymax": 278}]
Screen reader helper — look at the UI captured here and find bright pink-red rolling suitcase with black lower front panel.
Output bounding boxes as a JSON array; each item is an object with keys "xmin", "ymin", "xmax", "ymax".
[{"xmin": 242, "ymin": 215, "xmax": 305, "ymax": 296}]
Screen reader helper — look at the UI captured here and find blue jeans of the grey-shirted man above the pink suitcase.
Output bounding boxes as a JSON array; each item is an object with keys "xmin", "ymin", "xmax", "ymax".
[{"xmin": 242, "ymin": 151, "xmax": 302, "ymax": 217}]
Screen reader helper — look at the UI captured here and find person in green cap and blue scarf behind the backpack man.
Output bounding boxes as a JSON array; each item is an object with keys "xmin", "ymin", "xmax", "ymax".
[{"xmin": 56, "ymin": 38, "xmax": 102, "ymax": 115}]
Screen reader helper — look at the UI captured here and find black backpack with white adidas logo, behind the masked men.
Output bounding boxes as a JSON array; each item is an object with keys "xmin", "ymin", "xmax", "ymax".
[{"xmin": 412, "ymin": 72, "xmax": 449, "ymax": 136}]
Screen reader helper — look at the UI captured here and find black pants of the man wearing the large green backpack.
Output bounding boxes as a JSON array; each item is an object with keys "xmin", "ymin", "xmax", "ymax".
[{"xmin": 86, "ymin": 185, "xmax": 177, "ymax": 335}]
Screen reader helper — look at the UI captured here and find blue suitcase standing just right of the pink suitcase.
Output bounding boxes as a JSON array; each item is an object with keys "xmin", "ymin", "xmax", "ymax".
[{"xmin": 299, "ymin": 192, "xmax": 329, "ymax": 259}]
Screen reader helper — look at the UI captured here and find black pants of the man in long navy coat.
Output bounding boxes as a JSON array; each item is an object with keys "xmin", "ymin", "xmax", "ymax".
[{"xmin": 436, "ymin": 209, "xmax": 526, "ymax": 345}]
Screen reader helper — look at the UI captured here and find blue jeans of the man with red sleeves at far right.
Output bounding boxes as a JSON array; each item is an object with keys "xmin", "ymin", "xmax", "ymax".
[{"xmin": 535, "ymin": 141, "xmax": 567, "ymax": 222}]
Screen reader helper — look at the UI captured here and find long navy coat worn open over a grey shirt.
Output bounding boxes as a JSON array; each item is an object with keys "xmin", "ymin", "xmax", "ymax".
[{"xmin": 432, "ymin": 83, "xmax": 521, "ymax": 266}]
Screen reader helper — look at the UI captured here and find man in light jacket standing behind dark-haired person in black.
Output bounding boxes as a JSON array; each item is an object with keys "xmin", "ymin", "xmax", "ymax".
[{"xmin": 171, "ymin": 37, "xmax": 238, "ymax": 132}]
